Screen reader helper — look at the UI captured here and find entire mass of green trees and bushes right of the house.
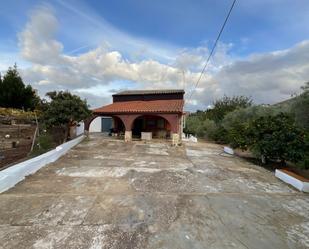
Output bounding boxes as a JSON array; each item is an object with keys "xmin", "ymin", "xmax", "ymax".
[{"xmin": 185, "ymin": 91, "xmax": 309, "ymax": 169}]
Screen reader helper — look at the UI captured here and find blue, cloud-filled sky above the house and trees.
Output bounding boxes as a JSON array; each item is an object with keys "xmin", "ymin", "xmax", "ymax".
[{"xmin": 0, "ymin": 0, "xmax": 309, "ymax": 111}]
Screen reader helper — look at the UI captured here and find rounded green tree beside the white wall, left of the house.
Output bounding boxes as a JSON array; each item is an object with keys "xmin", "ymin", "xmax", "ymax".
[{"xmin": 44, "ymin": 91, "xmax": 91, "ymax": 140}]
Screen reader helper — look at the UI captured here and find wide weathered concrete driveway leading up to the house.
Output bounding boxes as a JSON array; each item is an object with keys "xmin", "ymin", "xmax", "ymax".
[{"xmin": 0, "ymin": 135, "xmax": 309, "ymax": 249}]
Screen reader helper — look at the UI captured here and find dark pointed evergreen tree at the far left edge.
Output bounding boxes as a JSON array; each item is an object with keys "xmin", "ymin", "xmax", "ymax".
[{"xmin": 0, "ymin": 64, "xmax": 39, "ymax": 110}]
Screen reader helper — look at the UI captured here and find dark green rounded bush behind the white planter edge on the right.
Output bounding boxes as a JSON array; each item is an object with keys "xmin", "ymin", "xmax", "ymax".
[{"xmin": 246, "ymin": 113, "xmax": 305, "ymax": 163}]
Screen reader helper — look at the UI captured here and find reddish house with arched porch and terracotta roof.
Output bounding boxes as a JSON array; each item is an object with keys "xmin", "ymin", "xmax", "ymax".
[{"xmin": 85, "ymin": 89, "xmax": 185, "ymax": 144}]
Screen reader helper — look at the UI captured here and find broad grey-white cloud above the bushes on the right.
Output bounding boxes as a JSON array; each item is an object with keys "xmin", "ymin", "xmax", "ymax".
[{"xmin": 214, "ymin": 41, "xmax": 309, "ymax": 103}]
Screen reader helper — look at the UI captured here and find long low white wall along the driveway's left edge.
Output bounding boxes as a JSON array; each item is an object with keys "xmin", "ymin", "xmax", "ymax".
[{"xmin": 0, "ymin": 136, "xmax": 85, "ymax": 193}]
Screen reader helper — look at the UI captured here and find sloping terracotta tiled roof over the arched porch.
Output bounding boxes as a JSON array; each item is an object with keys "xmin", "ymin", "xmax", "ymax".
[{"xmin": 93, "ymin": 99, "xmax": 184, "ymax": 114}]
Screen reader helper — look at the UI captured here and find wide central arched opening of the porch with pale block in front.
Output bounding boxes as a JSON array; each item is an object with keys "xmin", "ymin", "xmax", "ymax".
[{"xmin": 132, "ymin": 115, "xmax": 171, "ymax": 139}]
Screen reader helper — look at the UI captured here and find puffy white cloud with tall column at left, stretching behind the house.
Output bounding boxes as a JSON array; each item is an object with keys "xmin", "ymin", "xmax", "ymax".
[{"xmin": 19, "ymin": 7, "xmax": 207, "ymax": 106}]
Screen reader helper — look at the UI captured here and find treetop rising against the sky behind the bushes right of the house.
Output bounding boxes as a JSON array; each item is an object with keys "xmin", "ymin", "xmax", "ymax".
[{"xmin": 205, "ymin": 96, "xmax": 252, "ymax": 123}]
